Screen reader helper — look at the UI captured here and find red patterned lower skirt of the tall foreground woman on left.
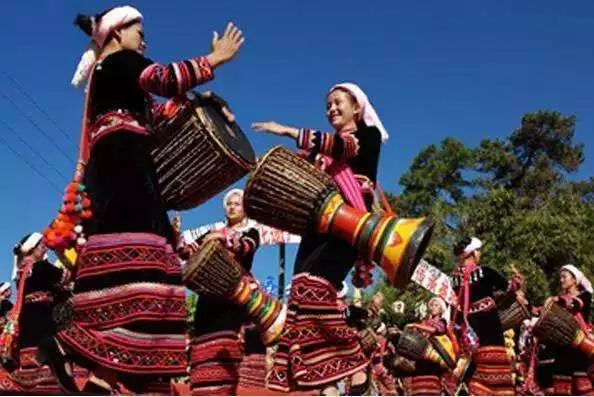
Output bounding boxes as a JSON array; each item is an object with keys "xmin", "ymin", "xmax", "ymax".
[{"xmin": 58, "ymin": 233, "xmax": 187, "ymax": 384}]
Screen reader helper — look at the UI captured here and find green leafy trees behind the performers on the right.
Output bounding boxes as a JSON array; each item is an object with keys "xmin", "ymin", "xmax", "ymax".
[{"xmin": 377, "ymin": 111, "xmax": 594, "ymax": 318}]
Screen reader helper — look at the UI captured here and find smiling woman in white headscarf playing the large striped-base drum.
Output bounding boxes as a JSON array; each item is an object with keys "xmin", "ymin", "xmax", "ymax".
[{"xmin": 252, "ymin": 83, "xmax": 388, "ymax": 394}]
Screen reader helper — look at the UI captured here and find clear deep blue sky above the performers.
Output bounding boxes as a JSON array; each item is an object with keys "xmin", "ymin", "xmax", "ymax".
[{"xmin": 0, "ymin": 0, "xmax": 594, "ymax": 279}]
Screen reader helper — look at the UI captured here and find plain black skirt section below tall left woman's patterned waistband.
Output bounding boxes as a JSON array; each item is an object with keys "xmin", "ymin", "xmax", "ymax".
[{"xmin": 84, "ymin": 131, "xmax": 174, "ymax": 244}]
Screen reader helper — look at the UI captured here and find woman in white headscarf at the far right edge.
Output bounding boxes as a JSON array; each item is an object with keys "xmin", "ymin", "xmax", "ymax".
[{"xmin": 549, "ymin": 264, "xmax": 594, "ymax": 395}]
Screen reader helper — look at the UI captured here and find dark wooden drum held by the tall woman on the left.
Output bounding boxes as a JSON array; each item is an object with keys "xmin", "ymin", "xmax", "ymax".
[{"xmin": 151, "ymin": 95, "xmax": 255, "ymax": 210}]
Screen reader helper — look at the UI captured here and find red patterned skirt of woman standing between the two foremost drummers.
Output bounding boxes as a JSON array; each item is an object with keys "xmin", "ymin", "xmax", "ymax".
[{"xmin": 190, "ymin": 331, "xmax": 241, "ymax": 396}]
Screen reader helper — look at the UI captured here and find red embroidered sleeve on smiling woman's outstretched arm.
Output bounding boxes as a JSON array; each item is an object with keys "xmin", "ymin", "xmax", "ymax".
[{"xmin": 297, "ymin": 128, "xmax": 359, "ymax": 159}]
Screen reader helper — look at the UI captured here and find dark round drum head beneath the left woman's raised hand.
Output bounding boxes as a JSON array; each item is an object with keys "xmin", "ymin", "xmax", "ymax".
[{"xmin": 193, "ymin": 97, "xmax": 256, "ymax": 164}]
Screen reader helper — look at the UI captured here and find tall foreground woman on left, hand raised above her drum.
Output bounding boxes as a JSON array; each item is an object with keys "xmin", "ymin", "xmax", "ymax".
[{"xmin": 45, "ymin": 6, "xmax": 243, "ymax": 394}]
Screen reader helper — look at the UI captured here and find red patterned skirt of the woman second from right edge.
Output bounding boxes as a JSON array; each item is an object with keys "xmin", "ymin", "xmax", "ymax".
[{"xmin": 468, "ymin": 346, "xmax": 515, "ymax": 396}]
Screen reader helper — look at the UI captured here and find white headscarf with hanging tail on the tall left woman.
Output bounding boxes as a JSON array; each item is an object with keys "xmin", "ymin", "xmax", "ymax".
[{"xmin": 71, "ymin": 6, "xmax": 143, "ymax": 87}]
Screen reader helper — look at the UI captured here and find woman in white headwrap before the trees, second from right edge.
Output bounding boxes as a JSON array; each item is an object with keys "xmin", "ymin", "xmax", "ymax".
[{"xmin": 452, "ymin": 237, "xmax": 523, "ymax": 395}]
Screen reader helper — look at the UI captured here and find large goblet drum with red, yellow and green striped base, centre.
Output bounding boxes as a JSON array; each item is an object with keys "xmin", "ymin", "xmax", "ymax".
[{"xmin": 244, "ymin": 146, "xmax": 433, "ymax": 287}]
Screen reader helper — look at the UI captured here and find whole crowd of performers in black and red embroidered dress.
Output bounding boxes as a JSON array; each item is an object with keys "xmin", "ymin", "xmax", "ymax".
[{"xmin": 0, "ymin": 6, "xmax": 594, "ymax": 395}]
